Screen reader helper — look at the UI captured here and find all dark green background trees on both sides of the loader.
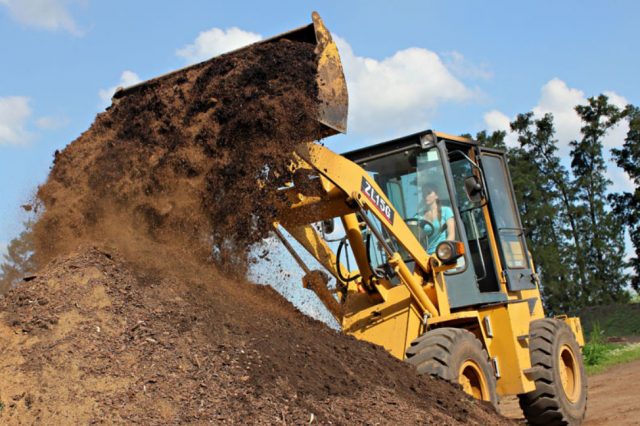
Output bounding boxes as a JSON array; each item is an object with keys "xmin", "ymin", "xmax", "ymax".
[{"xmin": 0, "ymin": 95, "xmax": 640, "ymax": 313}]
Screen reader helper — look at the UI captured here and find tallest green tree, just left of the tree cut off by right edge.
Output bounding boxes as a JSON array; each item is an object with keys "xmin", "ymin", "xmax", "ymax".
[{"xmin": 570, "ymin": 95, "xmax": 629, "ymax": 305}]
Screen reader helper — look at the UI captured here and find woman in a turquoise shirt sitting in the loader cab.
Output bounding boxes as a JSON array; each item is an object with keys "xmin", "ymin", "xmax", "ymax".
[{"xmin": 422, "ymin": 184, "xmax": 456, "ymax": 254}]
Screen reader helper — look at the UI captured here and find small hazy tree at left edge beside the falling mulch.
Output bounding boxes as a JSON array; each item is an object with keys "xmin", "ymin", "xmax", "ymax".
[{"xmin": 0, "ymin": 221, "xmax": 36, "ymax": 294}]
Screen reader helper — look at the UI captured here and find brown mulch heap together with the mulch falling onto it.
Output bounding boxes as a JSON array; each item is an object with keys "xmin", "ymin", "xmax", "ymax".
[{"xmin": 0, "ymin": 41, "xmax": 510, "ymax": 425}]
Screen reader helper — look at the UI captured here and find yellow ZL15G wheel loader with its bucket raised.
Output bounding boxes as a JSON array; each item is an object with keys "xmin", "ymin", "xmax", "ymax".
[{"xmin": 115, "ymin": 12, "xmax": 587, "ymax": 424}]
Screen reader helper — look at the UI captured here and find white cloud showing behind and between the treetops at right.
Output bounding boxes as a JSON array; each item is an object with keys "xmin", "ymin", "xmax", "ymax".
[{"xmin": 484, "ymin": 78, "xmax": 633, "ymax": 192}]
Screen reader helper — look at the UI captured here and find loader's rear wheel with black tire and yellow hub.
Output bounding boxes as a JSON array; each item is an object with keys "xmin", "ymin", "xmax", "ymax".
[{"xmin": 518, "ymin": 318, "xmax": 587, "ymax": 425}]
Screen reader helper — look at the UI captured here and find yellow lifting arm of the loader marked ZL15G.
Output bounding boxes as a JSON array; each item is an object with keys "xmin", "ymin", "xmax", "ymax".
[{"xmin": 279, "ymin": 142, "xmax": 448, "ymax": 317}]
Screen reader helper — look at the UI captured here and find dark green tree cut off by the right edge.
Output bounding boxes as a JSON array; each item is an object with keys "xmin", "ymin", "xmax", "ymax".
[{"xmin": 609, "ymin": 105, "xmax": 640, "ymax": 292}]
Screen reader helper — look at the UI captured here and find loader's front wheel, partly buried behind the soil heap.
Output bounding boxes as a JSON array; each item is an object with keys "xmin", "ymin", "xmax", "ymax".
[{"xmin": 406, "ymin": 328, "xmax": 498, "ymax": 406}]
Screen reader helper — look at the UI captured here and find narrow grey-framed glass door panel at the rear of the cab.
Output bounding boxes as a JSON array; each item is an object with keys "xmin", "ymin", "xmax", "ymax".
[{"xmin": 480, "ymin": 148, "xmax": 536, "ymax": 291}]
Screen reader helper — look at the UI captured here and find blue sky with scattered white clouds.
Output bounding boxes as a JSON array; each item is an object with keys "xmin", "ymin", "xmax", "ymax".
[{"xmin": 0, "ymin": 0, "xmax": 640, "ymax": 258}]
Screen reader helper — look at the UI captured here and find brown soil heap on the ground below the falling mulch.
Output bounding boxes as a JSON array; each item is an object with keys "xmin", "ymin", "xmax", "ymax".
[{"xmin": 0, "ymin": 247, "xmax": 503, "ymax": 424}]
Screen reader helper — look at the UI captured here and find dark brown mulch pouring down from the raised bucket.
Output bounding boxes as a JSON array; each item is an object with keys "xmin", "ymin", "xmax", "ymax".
[{"xmin": 35, "ymin": 40, "xmax": 326, "ymax": 266}]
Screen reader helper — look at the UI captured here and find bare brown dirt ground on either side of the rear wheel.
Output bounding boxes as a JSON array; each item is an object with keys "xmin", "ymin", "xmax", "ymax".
[{"xmin": 500, "ymin": 361, "xmax": 640, "ymax": 426}]
